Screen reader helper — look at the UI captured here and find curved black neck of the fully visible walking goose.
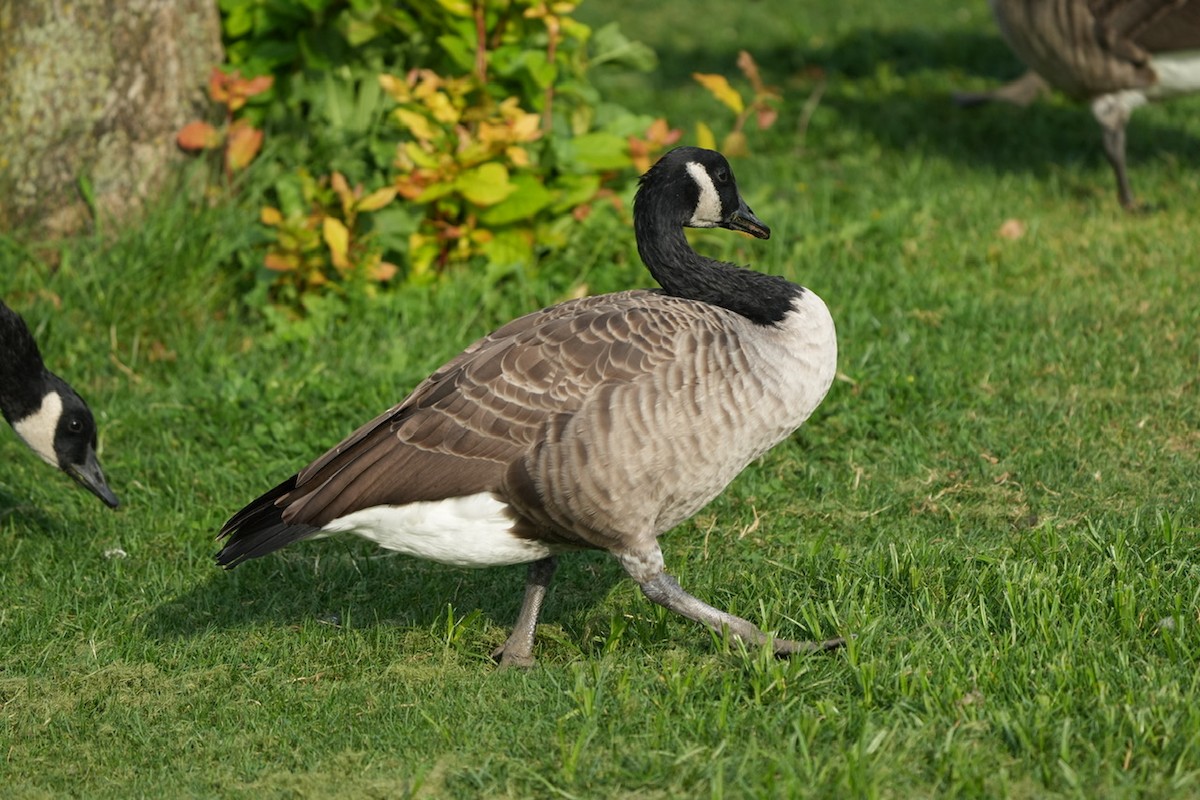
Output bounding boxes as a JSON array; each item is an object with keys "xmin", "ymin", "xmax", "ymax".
[{"xmin": 634, "ymin": 213, "xmax": 804, "ymax": 325}]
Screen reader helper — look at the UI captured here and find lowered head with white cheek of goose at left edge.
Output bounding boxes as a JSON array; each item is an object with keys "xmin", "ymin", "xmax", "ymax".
[{"xmin": 10, "ymin": 372, "xmax": 119, "ymax": 509}]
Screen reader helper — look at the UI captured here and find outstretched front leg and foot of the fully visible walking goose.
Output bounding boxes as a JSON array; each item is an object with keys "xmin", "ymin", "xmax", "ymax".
[{"xmin": 618, "ymin": 546, "xmax": 846, "ymax": 656}]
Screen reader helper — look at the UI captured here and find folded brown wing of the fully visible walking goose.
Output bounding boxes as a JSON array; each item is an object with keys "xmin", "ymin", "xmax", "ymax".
[{"xmin": 276, "ymin": 291, "xmax": 695, "ymax": 527}]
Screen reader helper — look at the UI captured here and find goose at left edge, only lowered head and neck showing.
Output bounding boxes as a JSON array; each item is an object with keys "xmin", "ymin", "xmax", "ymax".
[{"xmin": 0, "ymin": 297, "xmax": 118, "ymax": 509}]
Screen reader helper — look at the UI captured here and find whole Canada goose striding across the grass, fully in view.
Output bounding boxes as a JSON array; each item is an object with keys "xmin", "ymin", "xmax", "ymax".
[{"xmin": 216, "ymin": 148, "xmax": 841, "ymax": 666}]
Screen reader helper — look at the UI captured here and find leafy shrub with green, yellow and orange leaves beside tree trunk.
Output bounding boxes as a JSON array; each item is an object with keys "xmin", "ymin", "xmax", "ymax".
[{"xmin": 199, "ymin": 0, "xmax": 678, "ymax": 307}]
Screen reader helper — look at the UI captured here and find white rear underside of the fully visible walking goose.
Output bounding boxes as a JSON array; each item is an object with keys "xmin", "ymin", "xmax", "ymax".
[{"xmin": 322, "ymin": 492, "xmax": 553, "ymax": 567}]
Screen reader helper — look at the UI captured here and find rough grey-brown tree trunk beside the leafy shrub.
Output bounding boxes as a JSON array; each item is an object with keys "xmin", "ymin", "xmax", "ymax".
[{"xmin": 0, "ymin": 0, "xmax": 222, "ymax": 235}]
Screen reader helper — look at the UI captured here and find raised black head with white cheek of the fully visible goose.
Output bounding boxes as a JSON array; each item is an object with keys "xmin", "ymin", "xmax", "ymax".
[{"xmin": 634, "ymin": 148, "xmax": 770, "ymax": 239}]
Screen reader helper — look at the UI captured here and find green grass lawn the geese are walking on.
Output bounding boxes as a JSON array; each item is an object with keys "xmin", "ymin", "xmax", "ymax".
[{"xmin": 0, "ymin": 0, "xmax": 1200, "ymax": 798}]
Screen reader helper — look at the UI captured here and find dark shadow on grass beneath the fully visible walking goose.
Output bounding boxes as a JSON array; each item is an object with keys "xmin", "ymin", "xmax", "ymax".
[{"xmin": 139, "ymin": 540, "xmax": 624, "ymax": 645}]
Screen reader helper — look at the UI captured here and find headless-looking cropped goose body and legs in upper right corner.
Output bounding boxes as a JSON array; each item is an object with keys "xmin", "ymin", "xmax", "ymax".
[{"xmin": 956, "ymin": 0, "xmax": 1200, "ymax": 209}]
